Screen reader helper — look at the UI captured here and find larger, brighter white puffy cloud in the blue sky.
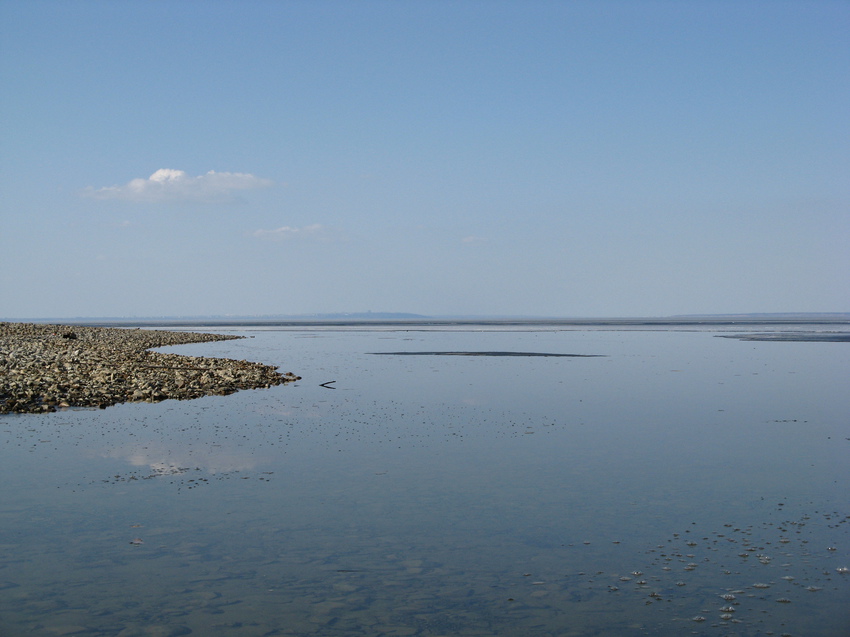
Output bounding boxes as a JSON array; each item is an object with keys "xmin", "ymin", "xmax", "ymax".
[{"xmin": 83, "ymin": 168, "xmax": 272, "ymax": 202}]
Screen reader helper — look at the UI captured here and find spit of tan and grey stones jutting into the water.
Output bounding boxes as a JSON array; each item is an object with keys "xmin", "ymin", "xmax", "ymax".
[{"xmin": 0, "ymin": 322, "xmax": 300, "ymax": 413}]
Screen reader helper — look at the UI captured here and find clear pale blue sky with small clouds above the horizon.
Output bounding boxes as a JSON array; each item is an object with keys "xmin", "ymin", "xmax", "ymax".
[{"xmin": 0, "ymin": 0, "xmax": 850, "ymax": 319}]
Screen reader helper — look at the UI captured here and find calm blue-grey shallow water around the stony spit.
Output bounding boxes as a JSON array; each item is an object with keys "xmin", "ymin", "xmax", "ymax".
[{"xmin": 0, "ymin": 326, "xmax": 850, "ymax": 637}]
